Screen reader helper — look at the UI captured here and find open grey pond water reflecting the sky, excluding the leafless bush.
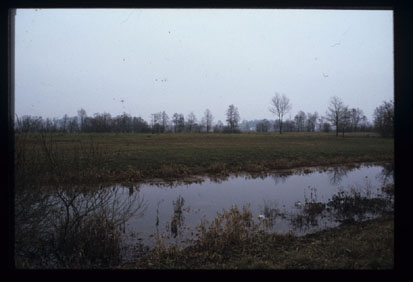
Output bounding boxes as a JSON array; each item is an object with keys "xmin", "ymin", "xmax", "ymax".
[{"xmin": 112, "ymin": 165, "xmax": 393, "ymax": 251}]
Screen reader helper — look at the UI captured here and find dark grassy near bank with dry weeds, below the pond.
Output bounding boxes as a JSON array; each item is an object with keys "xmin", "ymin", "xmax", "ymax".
[{"xmin": 131, "ymin": 211, "xmax": 394, "ymax": 269}]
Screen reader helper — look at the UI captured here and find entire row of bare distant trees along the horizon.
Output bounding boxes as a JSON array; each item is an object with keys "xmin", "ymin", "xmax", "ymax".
[{"xmin": 15, "ymin": 94, "xmax": 394, "ymax": 137}]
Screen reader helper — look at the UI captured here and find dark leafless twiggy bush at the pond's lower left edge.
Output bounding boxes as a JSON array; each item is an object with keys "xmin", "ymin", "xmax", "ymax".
[{"xmin": 15, "ymin": 186, "xmax": 146, "ymax": 268}]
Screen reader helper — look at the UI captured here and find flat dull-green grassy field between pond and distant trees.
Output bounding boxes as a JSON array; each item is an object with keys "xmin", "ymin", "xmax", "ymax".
[{"xmin": 16, "ymin": 133, "xmax": 394, "ymax": 184}]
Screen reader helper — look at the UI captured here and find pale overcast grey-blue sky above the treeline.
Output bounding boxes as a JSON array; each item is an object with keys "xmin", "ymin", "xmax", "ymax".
[{"xmin": 15, "ymin": 9, "xmax": 394, "ymax": 122}]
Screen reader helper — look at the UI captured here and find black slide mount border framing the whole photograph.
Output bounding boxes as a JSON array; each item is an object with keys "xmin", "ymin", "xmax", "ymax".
[{"xmin": 0, "ymin": 0, "xmax": 413, "ymax": 280}]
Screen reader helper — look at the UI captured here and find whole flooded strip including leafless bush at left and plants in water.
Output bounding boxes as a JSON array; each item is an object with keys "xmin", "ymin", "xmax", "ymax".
[{"xmin": 16, "ymin": 164, "xmax": 394, "ymax": 265}]
